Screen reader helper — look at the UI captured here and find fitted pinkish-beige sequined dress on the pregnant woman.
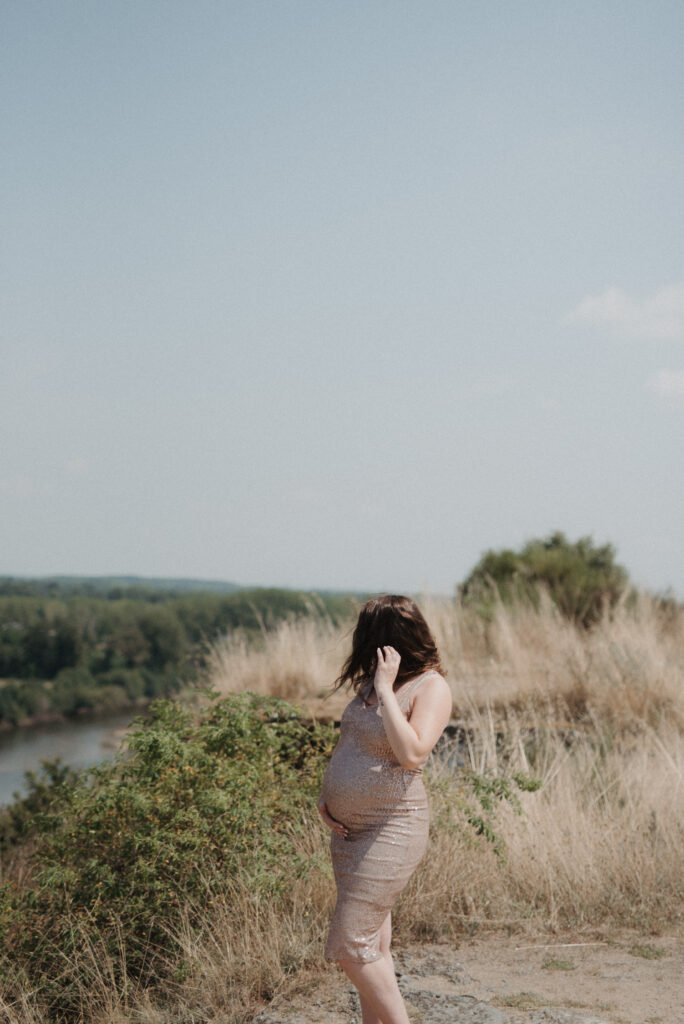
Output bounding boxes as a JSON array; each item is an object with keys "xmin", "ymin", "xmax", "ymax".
[{"xmin": 320, "ymin": 670, "xmax": 434, "ymax": 963}]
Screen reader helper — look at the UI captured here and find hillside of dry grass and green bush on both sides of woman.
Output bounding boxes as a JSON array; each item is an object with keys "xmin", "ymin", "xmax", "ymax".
[{"xmin": 0, "ymin": 594, "xmax": 684, "ymax": 1024}]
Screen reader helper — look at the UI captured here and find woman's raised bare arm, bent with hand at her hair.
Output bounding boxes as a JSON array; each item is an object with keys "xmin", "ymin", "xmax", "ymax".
[{"xmin": 375, "ymin": 648, "xmax": 453, "ymax": 768}]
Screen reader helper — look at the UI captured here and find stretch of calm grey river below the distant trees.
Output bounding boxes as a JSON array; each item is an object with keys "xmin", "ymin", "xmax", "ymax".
[{"xmin": 0, "ymin": 710, "xmax": 148, "ymax": 806}]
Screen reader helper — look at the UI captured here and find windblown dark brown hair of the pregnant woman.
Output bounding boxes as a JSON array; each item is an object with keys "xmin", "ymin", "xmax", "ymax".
[{"xmin": 333, "ymin": 594, "xmax": 444, "ymax": 693}]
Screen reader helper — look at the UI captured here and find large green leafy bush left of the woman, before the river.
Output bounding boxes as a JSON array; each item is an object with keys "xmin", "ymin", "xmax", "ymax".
[{"xmin": 0, "ymin": 693, "xmax": 336, "ymax": 1016}]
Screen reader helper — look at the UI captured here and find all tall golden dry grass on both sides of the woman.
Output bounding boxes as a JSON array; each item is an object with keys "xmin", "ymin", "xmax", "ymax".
[{"xmin": 0, "ymin": 595, "xmax": 684, "ymax": 1024}]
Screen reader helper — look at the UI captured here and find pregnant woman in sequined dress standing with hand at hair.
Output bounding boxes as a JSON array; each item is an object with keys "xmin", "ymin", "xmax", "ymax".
[{"xmin": 318, "ymin": 594, "xmax": 452, "ymax": 1024}]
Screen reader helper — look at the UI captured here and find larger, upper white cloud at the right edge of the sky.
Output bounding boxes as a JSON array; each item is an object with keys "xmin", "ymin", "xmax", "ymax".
[{"xmin": 565, "ymin": 282, "xmax": 684, "ymax": 341}]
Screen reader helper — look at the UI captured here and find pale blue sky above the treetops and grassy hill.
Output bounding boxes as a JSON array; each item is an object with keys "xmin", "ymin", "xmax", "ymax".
[{"xmin": 0, "ymin": 0, "xmax": 684, "ymax": 596}]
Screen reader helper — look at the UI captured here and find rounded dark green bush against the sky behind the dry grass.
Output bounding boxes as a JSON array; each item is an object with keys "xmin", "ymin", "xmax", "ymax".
[{"xmin": 458, "ymin": 530, "xmax": 629, "ymax": 627}]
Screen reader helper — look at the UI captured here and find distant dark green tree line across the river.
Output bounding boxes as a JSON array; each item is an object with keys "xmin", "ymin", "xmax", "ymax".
[{"xmin": 0, "ymin": 580, "xmax": 351, "ymax": 725}]
